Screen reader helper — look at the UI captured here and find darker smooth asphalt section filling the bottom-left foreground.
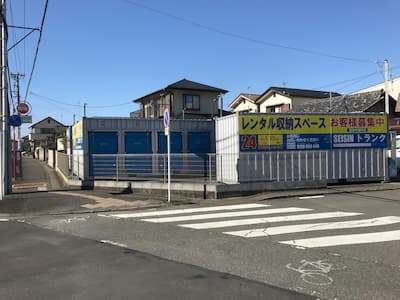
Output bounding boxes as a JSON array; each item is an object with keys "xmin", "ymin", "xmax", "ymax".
[{"xmin": 0, "ymin": 219, "xmax": 313, "ymax": 299}]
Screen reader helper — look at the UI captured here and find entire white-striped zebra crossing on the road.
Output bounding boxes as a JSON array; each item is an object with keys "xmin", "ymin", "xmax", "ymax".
[{"xmin": 99, "ymin": 203, "xmax": 400, "ymax": 248}]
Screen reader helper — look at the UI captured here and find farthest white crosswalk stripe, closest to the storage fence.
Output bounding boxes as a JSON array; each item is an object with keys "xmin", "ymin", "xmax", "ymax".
[{"xmin": 98, "ymin": 203, "xmax": 270, "ymax": 219}]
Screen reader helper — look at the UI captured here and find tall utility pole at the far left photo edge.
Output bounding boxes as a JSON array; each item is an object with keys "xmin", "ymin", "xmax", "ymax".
[{"xmin": 0, "ymin": 0, "xmax": 10, "ymax": 200}]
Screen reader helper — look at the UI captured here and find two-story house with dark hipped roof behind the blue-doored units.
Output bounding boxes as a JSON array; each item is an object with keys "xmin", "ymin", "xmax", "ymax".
[{"xmin": 133, "ymin": 79, "xmax": 228, "ymax": 119}]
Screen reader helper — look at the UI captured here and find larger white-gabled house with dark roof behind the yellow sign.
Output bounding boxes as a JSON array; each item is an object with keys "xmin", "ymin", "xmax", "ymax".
[{"xmin": 256, "ymin": 86, "xmax": 340, "ymax": 112}]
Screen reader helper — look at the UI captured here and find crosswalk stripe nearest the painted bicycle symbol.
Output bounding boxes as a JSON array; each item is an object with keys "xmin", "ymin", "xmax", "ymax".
[{"xmin": 279, "ymin": 230, "xmax": 400, "ymax": 248}]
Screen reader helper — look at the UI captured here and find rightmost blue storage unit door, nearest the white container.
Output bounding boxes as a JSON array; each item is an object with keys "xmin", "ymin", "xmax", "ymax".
[{"xmin": 188, "ymin": 132, "xmax": 210, "ymax": 176}]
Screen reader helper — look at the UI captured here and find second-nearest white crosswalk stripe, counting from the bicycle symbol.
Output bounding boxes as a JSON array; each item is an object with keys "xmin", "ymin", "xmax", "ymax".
[{"xmin": 224, "ymin": 216, "xmax": 400, "ymax": 238}]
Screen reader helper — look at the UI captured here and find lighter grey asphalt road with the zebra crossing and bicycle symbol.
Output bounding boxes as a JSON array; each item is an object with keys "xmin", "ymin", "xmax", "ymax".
[{"xmin": 25, "ymin": 190, "xmax": 400, "ymax": 300}]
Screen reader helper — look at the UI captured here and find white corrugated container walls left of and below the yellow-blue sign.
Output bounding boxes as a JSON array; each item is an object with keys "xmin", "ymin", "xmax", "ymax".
[{"xmin": 216, "ymin": 115, "xmax": 388, "ymax": 184}]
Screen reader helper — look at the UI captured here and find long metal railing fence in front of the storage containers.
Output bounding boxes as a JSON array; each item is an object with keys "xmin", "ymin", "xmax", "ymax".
[{"xmin": 72, "ymin": 149, "xmax": 387, "ymax": 183}]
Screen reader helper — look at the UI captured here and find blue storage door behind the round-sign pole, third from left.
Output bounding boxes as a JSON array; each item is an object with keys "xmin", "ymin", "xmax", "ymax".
[{"xmin": 157, "ymin": 132, "xmax": 182, "ymax": 171}]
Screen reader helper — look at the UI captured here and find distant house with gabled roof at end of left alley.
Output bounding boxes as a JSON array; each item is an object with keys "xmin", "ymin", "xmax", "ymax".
[{"xmin": 29, "ymin": 117, "xmax": 67, "ymax": 151}]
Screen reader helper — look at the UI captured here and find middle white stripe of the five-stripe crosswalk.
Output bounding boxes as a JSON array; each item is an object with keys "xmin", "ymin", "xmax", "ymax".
[{"xmin": 178, "ymin": 211, "xmax": 362, "ymax": 229}]
